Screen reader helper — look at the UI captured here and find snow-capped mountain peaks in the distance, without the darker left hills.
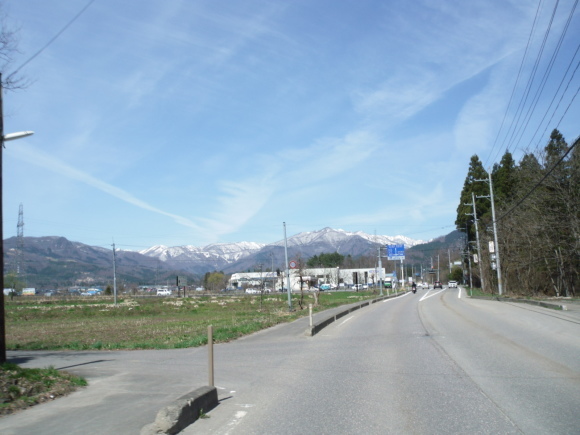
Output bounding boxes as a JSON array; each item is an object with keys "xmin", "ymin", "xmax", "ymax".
[{"xmin": 140, "ymin": 228, "xmax": 425, "ymax": 272}]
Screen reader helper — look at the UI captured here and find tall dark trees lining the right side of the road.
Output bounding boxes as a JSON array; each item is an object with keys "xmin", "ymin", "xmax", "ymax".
[{"xmin": 455, "ymin": 129, "xmax": 580, "ymax": 297}]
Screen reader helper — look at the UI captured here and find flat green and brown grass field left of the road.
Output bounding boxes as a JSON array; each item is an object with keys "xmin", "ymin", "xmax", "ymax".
[{"xmin": 5, "ymin": 292, "xmax": 376, "ymax": 350}]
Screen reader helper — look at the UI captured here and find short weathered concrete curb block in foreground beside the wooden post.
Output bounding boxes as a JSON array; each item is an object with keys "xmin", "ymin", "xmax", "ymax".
[{"xmin": 140, "ymin": 387, "xmax": 218, "ymax": 435}]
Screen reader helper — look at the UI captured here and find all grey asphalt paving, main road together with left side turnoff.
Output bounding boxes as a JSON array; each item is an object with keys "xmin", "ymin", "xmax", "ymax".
[{"xmin": 0, "ymin": 289, "xmax": 580, "ymax": 435}]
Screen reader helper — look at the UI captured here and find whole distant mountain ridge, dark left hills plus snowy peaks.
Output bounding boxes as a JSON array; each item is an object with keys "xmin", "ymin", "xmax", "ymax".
[{"xmin": 4, "ymin": 227, "xmax": 432, "ymax": 288}]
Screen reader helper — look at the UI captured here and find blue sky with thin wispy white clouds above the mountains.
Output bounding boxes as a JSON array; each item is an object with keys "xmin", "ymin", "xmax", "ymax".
[{"xmin": 2, "ymin": 0, "xmax": 580, "ymax": 250}]
